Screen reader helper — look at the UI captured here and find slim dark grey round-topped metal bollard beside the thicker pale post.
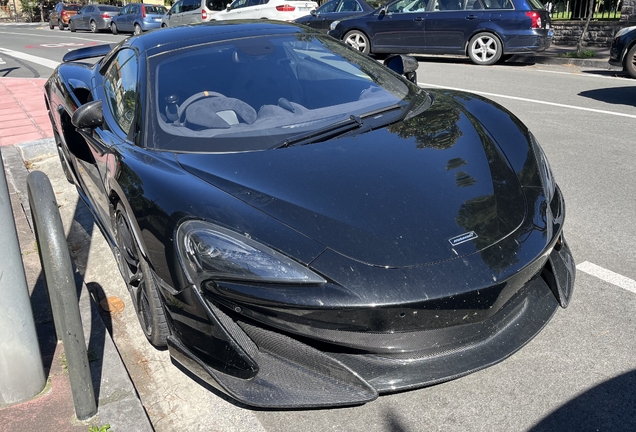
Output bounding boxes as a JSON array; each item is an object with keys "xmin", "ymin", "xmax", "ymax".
[{"xmin": 27, "ymin": 171, "xmax": 97, "ymax": 420}]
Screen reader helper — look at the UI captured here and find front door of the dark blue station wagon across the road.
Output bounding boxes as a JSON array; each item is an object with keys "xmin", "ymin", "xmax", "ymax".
[{"xmin": 368, "ymin": 0, "xmax": 433, "ymax": 53}]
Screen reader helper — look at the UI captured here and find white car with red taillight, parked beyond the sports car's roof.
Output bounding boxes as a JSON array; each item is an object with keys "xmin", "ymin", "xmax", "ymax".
[{"xmin": 211, "ymin": 0, "xmax": 318, "ymax": 21}]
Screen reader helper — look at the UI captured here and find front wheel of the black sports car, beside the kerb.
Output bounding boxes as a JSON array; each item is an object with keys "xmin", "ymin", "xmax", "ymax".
[{"xmin": 115, "ymin": 203, "xmax": 170, "ymax": 347}]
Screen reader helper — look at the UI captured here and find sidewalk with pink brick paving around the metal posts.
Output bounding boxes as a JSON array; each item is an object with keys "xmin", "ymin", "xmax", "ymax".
[{"xmin": 0, "ymin": 78, "xmax": 153, "ymax": 432}]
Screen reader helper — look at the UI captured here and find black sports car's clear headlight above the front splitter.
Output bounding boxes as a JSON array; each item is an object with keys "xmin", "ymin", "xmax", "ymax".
[{"xmin": 176, "ymin": 220, "xmax": 326, "ymax": 285}]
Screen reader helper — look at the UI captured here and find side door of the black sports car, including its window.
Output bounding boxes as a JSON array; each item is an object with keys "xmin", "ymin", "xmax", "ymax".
[{"xmin": 77, "ymin": 48, "xmax": 140, "ymax": 227}]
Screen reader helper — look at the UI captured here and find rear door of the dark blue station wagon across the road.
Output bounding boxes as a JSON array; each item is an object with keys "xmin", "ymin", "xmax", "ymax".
[{"xmin": 426, "ymin": 0, "xmax": 483, "ymax": 54}]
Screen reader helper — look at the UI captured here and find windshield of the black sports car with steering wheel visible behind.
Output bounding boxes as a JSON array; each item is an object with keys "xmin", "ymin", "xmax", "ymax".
[{"xmin": 146, "ymin": 33, "xmax": 419, "ymax": 152}]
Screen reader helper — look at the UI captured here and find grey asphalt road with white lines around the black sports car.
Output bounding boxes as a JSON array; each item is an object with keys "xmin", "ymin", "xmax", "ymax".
[{"xmin": 0, "ymin": 26, "xmax": 636, "ymax": 432}]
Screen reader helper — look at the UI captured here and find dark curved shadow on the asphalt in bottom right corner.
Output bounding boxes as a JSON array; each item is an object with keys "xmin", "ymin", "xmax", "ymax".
[{"xmin": 530, "ymin": 370, "xmax": 636, "ymax": 432}]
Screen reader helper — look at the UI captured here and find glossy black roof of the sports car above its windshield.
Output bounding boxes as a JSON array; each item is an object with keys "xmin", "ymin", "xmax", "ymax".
[{"xmin": 122, "ymin": 20, "xmax": 319, "ymax": 56}]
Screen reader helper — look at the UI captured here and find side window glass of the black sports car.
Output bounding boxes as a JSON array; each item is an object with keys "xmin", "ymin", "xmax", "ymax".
[{"xmin": 104, "ymin": 49, "xmax": 138, "ymax": 134}]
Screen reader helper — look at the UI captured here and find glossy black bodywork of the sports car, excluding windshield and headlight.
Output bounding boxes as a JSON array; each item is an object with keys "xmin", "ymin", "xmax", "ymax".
[{"xmin": 46, "ymin": 22, "xmax": 575, "ymax": 407}]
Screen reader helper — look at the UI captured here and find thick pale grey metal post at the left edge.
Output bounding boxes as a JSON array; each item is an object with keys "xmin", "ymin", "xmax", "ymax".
[{"xmin": 0, "ymin": 154, "xmax": 46, "ymax": 406}]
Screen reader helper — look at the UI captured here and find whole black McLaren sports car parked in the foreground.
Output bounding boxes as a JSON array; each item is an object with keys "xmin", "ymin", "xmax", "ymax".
[{"xmin": 46, "ymin": 21, "xmax": 575, "ymax": 407}]
